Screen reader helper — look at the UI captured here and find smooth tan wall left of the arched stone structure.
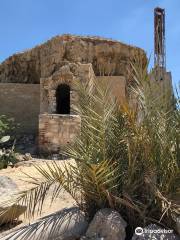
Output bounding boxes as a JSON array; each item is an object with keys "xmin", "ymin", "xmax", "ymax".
[{"xmin": 0, "ymin": 83, "xmax": 40, "ymax": 134}]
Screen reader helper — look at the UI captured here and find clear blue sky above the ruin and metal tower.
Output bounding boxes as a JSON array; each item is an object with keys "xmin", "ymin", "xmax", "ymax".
[{"xmin": 0, "ymin": 0, "xmax": 180, "ymax": 90}]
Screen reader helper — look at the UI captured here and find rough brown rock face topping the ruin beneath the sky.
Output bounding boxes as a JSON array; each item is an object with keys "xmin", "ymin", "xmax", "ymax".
[{"xmin": 0, "ymin": 35, "xmax": 146, "ymax": 86}]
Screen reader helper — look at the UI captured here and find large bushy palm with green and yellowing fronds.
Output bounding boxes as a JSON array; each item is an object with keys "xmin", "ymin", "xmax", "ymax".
[{"xmin": 1, "ymin": 61, "xmax": 180, "ymax": 233}]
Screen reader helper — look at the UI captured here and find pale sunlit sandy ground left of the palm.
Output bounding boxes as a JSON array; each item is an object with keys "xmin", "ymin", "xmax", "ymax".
[{"xmin": 0, "ymin": 159, "xmax": 75, "ymax": 237}]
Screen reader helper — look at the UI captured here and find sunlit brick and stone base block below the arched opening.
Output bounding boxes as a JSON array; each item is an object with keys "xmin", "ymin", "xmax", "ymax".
[{"xmin": 39, "ymin": 114, "xmax": 81, "ymax": 152}]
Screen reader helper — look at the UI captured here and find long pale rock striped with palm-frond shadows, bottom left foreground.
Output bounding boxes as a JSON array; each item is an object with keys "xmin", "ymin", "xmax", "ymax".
[{"xmin": 0, "ymin": 207, "xmax": 88, "ymax": 240}]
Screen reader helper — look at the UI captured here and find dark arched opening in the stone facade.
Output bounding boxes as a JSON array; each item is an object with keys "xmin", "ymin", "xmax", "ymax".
[{"xmin": 56, "ymin": 84, "xmax": 70, "ymax": 114}]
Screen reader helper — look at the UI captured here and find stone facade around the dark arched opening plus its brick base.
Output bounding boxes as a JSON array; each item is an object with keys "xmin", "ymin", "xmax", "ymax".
[{"xmin": 39, "ymin": 63, "xmax": 95, "ymax": 152}]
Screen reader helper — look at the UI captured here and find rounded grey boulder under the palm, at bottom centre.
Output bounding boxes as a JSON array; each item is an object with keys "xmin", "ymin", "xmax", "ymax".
[{"xmin": 82, "ymin": 208, "xmax": 127, "ymax": 240}]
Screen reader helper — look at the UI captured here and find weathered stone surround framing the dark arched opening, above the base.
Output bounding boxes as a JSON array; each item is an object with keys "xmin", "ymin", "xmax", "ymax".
[{"xmin": 40, "ymin": 63, "xmax": 95, "ymax": 114}]
